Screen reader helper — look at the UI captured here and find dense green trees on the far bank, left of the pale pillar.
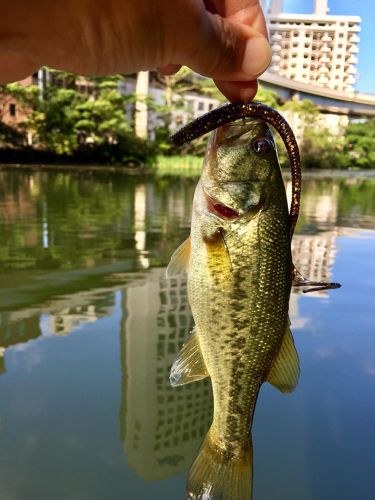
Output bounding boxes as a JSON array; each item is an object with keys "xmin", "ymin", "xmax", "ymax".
[{"xmin": 0, "ymin": 71, "xmax": 156, "ymax": 165}]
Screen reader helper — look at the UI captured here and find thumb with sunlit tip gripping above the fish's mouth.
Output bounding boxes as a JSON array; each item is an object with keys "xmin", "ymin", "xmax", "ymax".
[{"xmin": 184, "ymin": 12, "xmax": 271, "ymax": 82}]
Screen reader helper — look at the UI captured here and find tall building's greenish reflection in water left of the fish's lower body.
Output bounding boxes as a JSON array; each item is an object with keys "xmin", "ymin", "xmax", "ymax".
[{"xmin": 120, "ymin": 269, "xmax": 212, "ymax": 480}]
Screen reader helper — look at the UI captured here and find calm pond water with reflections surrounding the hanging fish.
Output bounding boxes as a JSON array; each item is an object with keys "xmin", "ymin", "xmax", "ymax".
[{"xmin": 0, "ymin": 170, "xmax": 375, "ymax": 500}]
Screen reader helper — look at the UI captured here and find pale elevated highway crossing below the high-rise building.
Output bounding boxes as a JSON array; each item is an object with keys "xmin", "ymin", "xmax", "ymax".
[{"xmin": 259, "ymin": 71, "xmax": 375, "ymax": 118}]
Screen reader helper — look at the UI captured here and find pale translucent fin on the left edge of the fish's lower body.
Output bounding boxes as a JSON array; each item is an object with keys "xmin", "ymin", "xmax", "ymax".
[{"xmin": 169, "ymin": 328, "xmax": 208, "ymax": 386}]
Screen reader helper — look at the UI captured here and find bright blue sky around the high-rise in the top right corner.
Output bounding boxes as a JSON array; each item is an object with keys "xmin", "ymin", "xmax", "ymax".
[{"xmin": 283, "ymin": 0, "xmax": 375, "ymax": 94}]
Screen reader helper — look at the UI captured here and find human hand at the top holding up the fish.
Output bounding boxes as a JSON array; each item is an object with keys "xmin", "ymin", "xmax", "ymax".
[{"xmin": 0, "ymin": 0, "xmax": 271, "ymax": 101}]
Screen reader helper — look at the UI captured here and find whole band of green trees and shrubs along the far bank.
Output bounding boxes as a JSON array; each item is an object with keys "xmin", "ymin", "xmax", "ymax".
[{"xmin": 0, "ymin": 68, "xmax": 375, "ymax": 168}]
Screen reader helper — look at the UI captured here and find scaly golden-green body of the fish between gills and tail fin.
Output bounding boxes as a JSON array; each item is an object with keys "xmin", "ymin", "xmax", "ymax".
[{"xmin": 188, "ymin": 205, "xmax": 291, "ymax": 454}]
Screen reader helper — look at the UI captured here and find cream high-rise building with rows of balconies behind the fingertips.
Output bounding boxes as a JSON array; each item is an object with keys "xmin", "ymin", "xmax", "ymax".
[{"xmin": 267, "ymin": 0, "xmax": 361, "ymax": 92}]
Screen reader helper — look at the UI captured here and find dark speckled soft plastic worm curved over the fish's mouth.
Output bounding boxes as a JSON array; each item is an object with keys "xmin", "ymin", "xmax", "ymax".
[{"xmin": 171, "ymin": 102, "xmax": 301, "ymax": 235}]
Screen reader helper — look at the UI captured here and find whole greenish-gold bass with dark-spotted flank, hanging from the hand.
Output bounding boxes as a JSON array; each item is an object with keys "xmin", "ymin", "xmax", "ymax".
[{"xmin": 167, "ymin": 105, "xmax": 340, "ymax": 500}]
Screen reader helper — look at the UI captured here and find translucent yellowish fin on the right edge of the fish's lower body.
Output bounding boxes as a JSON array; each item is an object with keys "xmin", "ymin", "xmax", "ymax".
[{"xmin": 267, "ymin": 325, "xmax": 299, "ymax": 392}]
